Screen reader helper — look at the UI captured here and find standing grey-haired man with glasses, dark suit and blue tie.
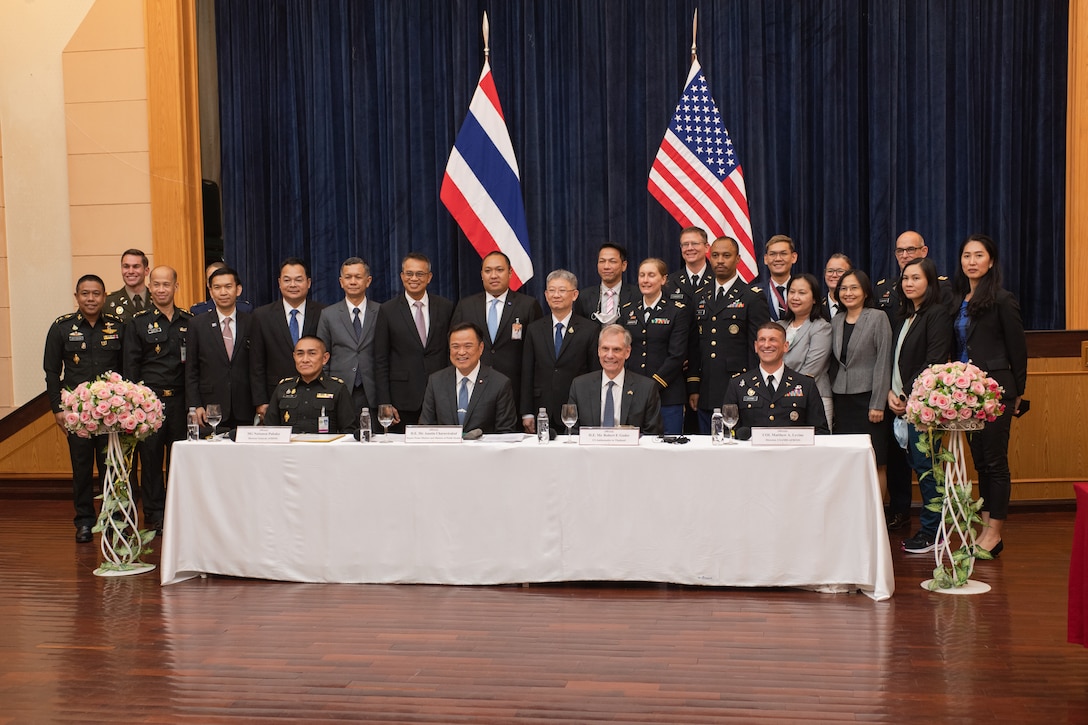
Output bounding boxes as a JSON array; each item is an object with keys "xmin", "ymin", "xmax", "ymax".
[{"xmin": 521, "ymin": 269, "xmax": 598, "ymax": 433}]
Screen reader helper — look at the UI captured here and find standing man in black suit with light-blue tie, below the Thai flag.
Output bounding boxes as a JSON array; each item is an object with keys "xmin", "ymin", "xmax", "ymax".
[{"xmin": 450, "ymin": 251, "xmax": 544, "ymax": 407}]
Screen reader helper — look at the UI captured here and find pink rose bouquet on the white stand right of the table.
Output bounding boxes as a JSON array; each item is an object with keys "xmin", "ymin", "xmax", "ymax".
[{"xmin": 906, "ymin": 361, "xmax": 1005, "ymax": 428}]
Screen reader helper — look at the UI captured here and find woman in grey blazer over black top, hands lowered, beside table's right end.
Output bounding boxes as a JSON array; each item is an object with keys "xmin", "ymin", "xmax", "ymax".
[{"xmin": 831, "ymin": 270, "xmax": 892, "ymax": 490}]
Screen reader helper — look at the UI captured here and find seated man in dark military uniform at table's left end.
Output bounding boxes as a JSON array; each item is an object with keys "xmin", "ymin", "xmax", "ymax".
[{"xmin": 264, "ymin": 335, "xmax": 359, "ymax": 433}]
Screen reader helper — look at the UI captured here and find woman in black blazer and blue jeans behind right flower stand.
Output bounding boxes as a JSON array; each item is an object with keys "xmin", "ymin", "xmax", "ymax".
[{"xmin": 888, "ymin": 257, "xmax": 952, "ymax": 554}]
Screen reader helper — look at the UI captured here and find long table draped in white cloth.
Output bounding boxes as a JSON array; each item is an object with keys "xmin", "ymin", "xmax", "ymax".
[{"xmin": 161, "ymin": 435, "xmax": 894, "ymax": 600}]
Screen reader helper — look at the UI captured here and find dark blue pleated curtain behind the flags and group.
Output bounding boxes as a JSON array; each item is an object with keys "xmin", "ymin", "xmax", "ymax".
[{"xmin": 215, "ymin": 0, "xmax": 1068, "ymax": 329}]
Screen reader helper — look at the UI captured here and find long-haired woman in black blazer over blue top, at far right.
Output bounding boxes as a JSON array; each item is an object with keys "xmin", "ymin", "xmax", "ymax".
[{"xmin": 951, "ymin": 234, "xmax": 1027, "ymax": 556}]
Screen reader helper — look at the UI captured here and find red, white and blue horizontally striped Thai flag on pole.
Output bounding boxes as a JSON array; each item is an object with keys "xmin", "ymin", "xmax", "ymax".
[{"xmin": 441, "ymin": 60, "xmax": 533, "ymax": 290}]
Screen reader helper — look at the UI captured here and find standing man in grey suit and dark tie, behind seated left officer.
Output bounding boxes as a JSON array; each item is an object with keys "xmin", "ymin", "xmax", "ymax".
[{"xmin": 318, "ymin": 257, "xmax": 381, "ymax": 419}]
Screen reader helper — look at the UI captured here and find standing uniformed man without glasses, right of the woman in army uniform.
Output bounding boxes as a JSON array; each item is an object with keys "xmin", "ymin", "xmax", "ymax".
[{"xmin": 688, "ymin": 236, "xmax": 769, "ymax": 434}]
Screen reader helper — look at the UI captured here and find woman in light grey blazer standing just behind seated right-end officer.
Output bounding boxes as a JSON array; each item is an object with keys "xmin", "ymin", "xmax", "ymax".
[{"xmin": 778, "ymin": 273, "xmax": 834, "ymax": 429}]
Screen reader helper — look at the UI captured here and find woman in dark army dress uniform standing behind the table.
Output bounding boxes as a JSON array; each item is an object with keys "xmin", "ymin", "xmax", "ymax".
[{"xmin": 617, "ymin": 257, "xmax": 691, "ymax": 435}]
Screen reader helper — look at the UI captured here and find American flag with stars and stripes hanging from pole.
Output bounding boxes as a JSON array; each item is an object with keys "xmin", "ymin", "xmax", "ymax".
[{"xmin": 647, "ymin": 60, "xmax": 757, "ymax": 282}]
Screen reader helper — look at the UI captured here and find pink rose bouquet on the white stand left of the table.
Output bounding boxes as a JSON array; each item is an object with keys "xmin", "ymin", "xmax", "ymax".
[{"xmin": 61, "ymin": 372, "xmax": 163, "ymax": 441}]
